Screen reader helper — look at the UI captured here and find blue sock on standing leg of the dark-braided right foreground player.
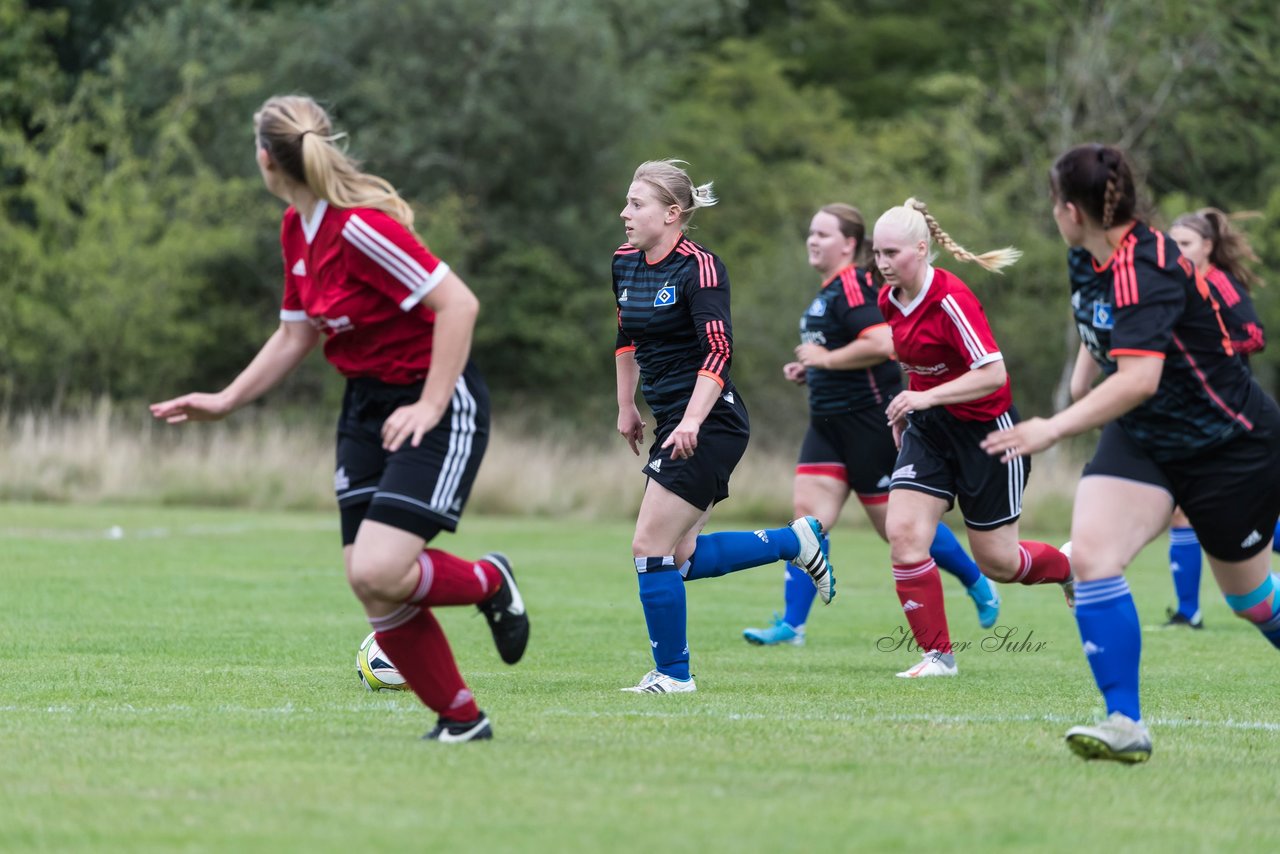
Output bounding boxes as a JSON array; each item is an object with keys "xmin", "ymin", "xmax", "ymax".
[{"xmin": 1075, "ymin": 576, "xmax": 1142, "ymax": 721}]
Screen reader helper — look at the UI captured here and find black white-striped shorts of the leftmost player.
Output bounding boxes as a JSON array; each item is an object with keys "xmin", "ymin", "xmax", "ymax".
[{"xmin": 333, "ymin": 364, "xmax": 489, "ymax": 545}]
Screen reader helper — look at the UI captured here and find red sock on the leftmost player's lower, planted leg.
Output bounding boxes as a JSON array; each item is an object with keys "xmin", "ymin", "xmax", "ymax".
[{"xmin": 370, "ymin": 604, "xmax": 480, "ymax": 721}]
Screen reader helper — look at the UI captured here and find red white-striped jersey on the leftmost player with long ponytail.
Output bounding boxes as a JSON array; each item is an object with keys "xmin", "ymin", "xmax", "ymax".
[{"xmin": 280, "ymin": 201, "xmax": 449, "ymax": 384}]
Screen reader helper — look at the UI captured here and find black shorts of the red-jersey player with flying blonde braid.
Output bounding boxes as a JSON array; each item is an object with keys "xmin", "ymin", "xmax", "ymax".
[{"xmin": 890, "ymin": 407, "xmax": 1032, "ymax": 531}]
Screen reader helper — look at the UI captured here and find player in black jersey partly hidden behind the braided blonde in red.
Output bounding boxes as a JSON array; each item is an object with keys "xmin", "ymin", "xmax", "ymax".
[{"xmin": 742, "ymin": 204, "xmax": 1000, "ymax": 645}]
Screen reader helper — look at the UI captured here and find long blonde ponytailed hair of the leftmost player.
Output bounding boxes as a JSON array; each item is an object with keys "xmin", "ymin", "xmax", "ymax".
[{"xmin": 253, "ymin": 95, "xmax": 413, "ymax": 229}]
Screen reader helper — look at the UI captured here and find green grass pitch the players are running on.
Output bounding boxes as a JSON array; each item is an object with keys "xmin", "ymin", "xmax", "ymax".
[{"xmin": 0, "ymin": 504, "xmax": 1280, "ymax": 853}]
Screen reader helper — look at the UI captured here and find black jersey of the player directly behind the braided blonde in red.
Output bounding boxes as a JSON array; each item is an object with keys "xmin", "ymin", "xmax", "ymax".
[{"xmin": 800, "ymin": 266, "xmax": 902, "ymax": 415}]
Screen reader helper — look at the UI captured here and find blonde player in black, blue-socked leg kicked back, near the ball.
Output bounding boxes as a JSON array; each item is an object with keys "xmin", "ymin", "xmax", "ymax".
[{"xmin": 613, "ymin": 160, "xmax": 835, "ymax": 694}]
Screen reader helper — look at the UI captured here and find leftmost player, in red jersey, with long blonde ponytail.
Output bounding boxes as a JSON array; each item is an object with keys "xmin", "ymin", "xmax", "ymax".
[{"xmin": 151, "ymin": 96, "xmax": 529, "ymax": 743}]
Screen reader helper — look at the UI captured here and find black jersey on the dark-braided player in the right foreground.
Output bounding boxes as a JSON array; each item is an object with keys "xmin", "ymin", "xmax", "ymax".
[{"xmin": 1070, "ymin": 223, "xmax": 1265, "ymax": 462}]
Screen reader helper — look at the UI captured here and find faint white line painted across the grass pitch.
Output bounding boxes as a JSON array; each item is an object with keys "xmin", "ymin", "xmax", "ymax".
[{"xmin": 0, "ymin": 695, "xmax": 1280, "ymax": 732}]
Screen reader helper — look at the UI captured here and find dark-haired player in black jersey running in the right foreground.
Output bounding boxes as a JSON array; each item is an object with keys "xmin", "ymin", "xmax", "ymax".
[{"xmin": 983, "ymin": 145, "xmax": 1280, "ymax": 762}]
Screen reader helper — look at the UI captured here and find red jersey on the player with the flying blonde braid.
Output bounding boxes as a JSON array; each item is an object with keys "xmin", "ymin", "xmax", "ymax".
[{"xmin": 879, "ymin": 266, "xmax": 1014, "ymax": 421}]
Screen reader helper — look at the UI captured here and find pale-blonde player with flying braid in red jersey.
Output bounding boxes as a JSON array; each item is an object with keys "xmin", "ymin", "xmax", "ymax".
[{"xmin": 872, "ymin": 198, "xmax": 1070, "ymax": 679}]
